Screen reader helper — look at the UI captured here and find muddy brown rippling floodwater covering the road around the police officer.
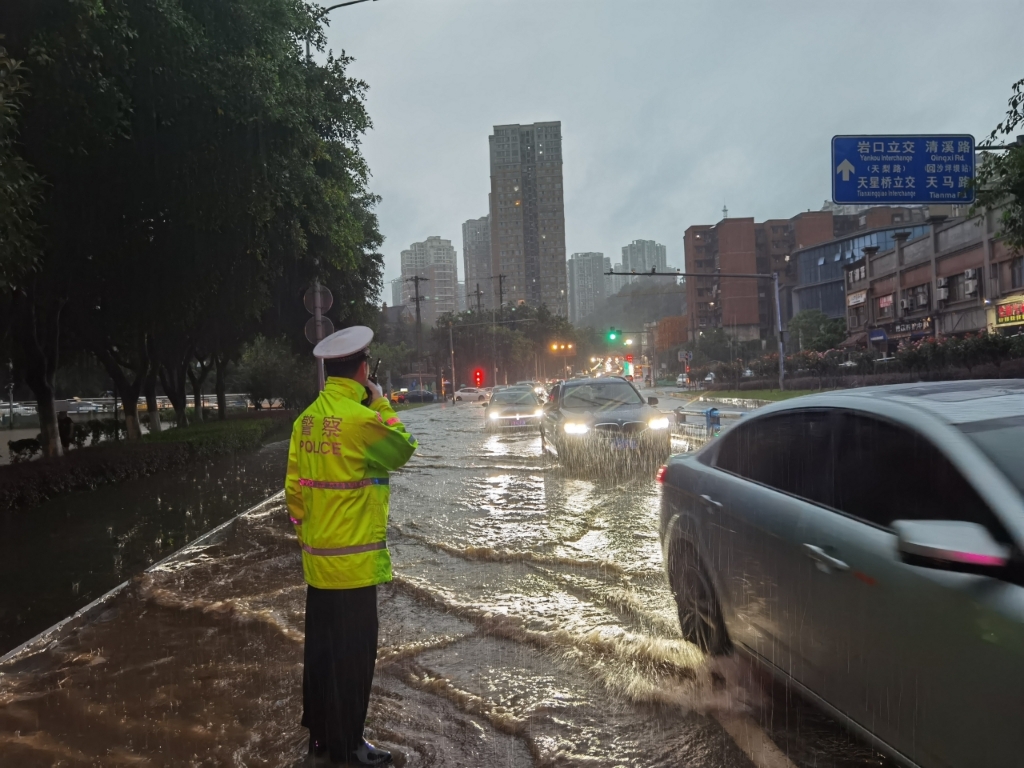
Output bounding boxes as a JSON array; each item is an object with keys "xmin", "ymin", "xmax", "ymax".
[{"xmin": 0, "ymin": 403, "xmax": 884, "ymax": 768}]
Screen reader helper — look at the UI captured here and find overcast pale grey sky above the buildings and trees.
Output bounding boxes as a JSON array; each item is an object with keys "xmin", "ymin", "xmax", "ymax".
[{"xmin": 324, "ymin": 0, "xmax": 1024, "ymax": 292}]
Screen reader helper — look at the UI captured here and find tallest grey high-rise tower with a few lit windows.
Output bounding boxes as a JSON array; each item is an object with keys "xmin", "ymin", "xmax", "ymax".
[{"xmin": 489, "ymin": 121, "xmax": 568, "ymax": 316}]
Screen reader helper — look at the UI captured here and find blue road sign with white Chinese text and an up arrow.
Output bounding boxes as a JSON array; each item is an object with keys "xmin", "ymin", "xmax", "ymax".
[{"xmin": 831, "ymin": 134, "xmax": 974, "ymax": 205}]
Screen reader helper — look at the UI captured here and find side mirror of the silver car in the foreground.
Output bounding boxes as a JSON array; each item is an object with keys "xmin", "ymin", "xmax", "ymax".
[{"xmin": 892, "ymin": 520, "xmax": 1010, "ymax": 574}]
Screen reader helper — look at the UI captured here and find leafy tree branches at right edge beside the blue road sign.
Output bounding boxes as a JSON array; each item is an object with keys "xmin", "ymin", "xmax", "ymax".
[{"xmin": 971, "ymin": 79, "xmax": 1024, "ymax": 252}]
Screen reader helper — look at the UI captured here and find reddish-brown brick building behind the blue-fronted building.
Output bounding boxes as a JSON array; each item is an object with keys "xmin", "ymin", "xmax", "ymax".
[{"xmin": 684, "ymin": 207, "xmax": 924, "ymax": 345}]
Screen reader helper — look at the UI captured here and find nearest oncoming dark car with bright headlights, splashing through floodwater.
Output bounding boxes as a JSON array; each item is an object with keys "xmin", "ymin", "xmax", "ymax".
[{"xmin": 541, "ymin": 377, "xmax": 672, "ymax": 465}]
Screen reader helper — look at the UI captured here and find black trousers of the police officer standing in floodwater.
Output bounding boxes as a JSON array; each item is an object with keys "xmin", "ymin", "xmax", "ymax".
[{"xmin": 302, "ymin": 586, "xmax": 377, "ymax": 760}]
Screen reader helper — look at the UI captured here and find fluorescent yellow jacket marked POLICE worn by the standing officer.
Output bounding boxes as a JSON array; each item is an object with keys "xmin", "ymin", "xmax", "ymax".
[{"xmin": 285, "ymin": 378, "xmax": 417, "ymax": 589}]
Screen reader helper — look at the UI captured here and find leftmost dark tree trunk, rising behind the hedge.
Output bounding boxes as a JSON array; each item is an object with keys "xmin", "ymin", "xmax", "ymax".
[{"xmin": 12, "ymin": 288, "xmax": 63, "ymax": 457}]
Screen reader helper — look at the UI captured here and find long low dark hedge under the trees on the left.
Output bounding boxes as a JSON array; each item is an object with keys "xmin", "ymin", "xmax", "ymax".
[{"xmin": 0, "ymin": 411, "xmax": 295, "ymax": 510}]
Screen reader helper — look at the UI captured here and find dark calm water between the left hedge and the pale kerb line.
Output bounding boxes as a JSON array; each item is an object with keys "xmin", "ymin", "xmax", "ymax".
[{"xmin": 0, "ymin": 442, "xmax": 288, "ymax": 655}]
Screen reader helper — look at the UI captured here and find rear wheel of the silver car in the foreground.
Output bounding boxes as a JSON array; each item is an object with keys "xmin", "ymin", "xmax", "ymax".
[{"xmin": 669, "ymin": 541, "xmax": 731, "ymax": 656}]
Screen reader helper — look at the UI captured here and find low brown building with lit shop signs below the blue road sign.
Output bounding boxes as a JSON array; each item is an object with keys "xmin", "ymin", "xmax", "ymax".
[{"xmin": 843, "ymin": 211, "xmax": 1024, "ymax": 356}]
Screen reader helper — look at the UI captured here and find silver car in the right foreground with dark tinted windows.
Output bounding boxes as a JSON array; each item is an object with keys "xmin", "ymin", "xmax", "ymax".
[{"xmin": 658, "ymin": 380, "xmax": 1024, "ymax": 768}]
